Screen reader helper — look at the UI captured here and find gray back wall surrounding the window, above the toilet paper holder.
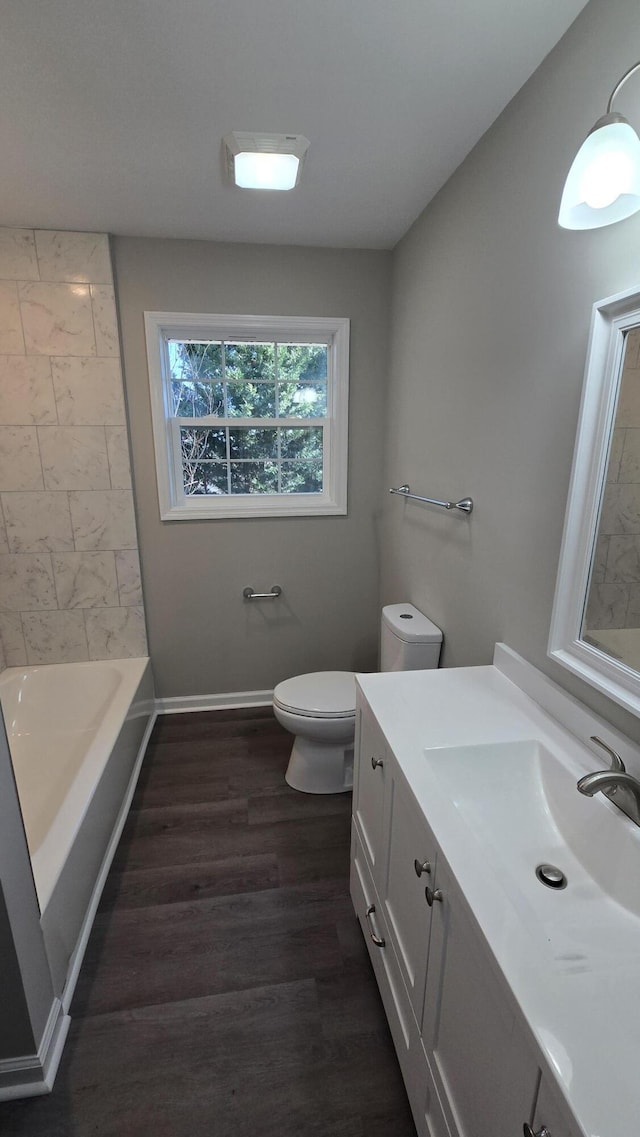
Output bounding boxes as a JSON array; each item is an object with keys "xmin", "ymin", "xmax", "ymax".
[{"xmin": 114, "ymin": 238, "xmax": 391, "ymax": 697}]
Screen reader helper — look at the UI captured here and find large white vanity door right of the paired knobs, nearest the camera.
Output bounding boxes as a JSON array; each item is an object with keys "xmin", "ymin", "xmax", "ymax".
[{"xmin": 423, "ymin": 856, "xmax": 538, "ymax": 1137}]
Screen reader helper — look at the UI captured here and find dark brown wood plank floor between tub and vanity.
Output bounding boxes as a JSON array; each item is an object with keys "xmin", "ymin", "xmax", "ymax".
[{"xmin": 0, "ymin": 709, "xmax": 415, "ymax": 1137}]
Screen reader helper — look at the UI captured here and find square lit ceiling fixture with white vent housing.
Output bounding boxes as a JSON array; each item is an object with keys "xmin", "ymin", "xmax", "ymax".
[{"xmin": 223, "ymin": 131, "xmax": 309, "ymax": 190}]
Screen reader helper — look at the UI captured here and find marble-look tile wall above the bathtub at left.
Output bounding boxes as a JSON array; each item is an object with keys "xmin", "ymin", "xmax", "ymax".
[{"xmin": 0, "ymin": 229, "xmax": 147, "ymax": 667}]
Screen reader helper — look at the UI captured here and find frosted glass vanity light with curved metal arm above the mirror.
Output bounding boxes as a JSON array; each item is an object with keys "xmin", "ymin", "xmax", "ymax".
[{"xmin": 558, "ymin": 63, "xmax": 640, "ymax": 229}]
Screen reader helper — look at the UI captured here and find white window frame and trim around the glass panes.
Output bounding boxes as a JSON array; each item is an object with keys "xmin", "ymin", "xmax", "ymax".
[{"xmin": 144, "ymin": 312, "xmax": 349, "ymax": 521}]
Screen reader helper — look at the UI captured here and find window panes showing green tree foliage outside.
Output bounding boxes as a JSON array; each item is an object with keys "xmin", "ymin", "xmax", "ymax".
[{"xmin": 168, "ymin": 340, "xmax": 327, "ymax": 496}]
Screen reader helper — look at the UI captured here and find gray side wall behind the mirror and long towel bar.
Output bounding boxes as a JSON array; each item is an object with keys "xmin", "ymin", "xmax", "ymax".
[{"xmin": 380, "ymin": 0, "xmax": 640, "ymax": 737}]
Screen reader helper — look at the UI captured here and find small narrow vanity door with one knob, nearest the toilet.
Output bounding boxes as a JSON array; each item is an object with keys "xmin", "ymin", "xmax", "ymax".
[{"xmin": 354, "ymin": 703, "xmax": 389, "ymax": 882}]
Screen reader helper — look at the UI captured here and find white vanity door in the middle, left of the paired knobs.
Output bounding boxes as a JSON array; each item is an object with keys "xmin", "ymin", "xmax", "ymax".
[{"xmin": 380, "ymin": 763, "xmax": 437, "ymax": 1023}]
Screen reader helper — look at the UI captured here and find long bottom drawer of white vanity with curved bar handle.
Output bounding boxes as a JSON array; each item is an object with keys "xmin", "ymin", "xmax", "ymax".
[{"xmin": 351, "ymin": 830, "xmax": 429, "ymax": 1137}]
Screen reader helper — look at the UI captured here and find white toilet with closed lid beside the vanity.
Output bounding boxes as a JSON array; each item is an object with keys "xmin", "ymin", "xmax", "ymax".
[{"xmin": 273, "ymin": 604, "xmax": 442, "ymax": 794}]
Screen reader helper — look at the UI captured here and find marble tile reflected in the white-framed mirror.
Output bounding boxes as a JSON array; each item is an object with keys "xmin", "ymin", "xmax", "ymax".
[{"xmin": 587, "ymin": 329, "xmax": 640, "ymax": 630}]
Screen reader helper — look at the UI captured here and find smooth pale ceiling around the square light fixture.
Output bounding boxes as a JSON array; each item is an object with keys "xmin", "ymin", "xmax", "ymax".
[{"xmin": 0, "ymin": 0, "xmax": 585, "ymax": 248}]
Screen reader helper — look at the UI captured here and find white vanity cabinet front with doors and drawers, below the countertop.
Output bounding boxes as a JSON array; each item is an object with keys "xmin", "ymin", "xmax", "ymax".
[{"xmin": 351, "ymin": 694, "xmax": 579, "ymax": 1137}]
